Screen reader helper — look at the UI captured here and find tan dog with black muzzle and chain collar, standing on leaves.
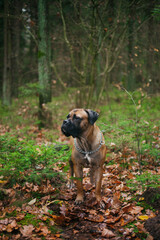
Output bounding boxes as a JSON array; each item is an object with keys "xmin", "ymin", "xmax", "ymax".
[{"xmin": 61, "ymin": 108, "xmax": 106, "ymax": 204}]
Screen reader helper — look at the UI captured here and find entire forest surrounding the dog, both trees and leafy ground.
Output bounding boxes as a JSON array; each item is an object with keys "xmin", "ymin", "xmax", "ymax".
[{"xmin": 0, "ymin": 0, "xmax": 160, "ymax": 239}]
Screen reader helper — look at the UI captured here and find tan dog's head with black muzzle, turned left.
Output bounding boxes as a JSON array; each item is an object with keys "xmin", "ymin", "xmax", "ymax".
[{"xmin": 61, "ymin": 109, "xmax": 99, "ymax": 138}]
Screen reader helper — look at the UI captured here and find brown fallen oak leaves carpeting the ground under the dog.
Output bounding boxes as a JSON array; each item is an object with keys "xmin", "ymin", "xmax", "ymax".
[{"xmin": 0, "ymin": 125, "xmax": 159, "ymax": 240}]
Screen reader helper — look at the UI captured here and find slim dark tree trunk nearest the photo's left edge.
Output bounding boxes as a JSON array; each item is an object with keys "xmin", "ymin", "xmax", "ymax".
[{"xmin": 2, "ymin": 0, "xmax": 11, "ymax": 106}]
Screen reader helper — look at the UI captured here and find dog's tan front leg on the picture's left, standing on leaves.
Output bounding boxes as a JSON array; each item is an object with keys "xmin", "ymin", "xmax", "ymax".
[{"xmin": 74, "ymin": 163, "xmax": 84, "ymax": 204}]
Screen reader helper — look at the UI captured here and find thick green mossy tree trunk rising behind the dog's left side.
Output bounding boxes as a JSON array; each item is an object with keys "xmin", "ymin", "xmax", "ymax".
[{"xmin": 38, "ymin": 0, "xmax": 51, "ymax": 127}]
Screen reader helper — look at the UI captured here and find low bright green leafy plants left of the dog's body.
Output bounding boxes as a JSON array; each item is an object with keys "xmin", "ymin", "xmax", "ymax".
[{"xmin": 0, "ymin": 134, "xmax": 70, "ymax": 186}]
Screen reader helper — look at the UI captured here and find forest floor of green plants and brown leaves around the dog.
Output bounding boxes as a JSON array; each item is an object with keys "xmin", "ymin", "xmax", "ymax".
[{"xmin": 0, "ymin": 89, "xmax": 160, "ymax": 240}]
